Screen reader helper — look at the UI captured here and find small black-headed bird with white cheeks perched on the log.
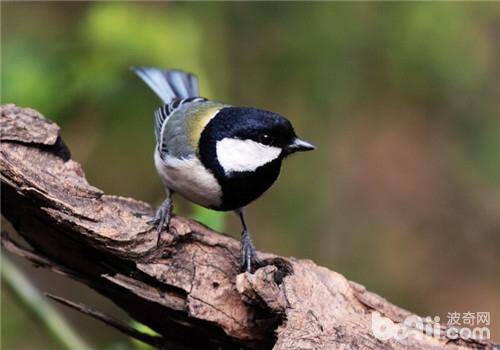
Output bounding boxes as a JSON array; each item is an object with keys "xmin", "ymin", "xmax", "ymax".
[{"xmin": 131, "ymin": 67, "xmax": 316, "ymax": 272}]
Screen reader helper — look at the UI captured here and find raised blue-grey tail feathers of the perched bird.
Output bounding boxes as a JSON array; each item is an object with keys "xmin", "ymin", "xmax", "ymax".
[{"xmin": 131, "ymin": 67, "xmax": 199, "ymax": 104}]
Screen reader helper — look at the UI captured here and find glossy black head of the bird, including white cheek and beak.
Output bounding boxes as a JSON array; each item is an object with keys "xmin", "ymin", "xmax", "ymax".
[{"xmin": 198, "ymin": 107, "xmax": 314, "ymax": 209}]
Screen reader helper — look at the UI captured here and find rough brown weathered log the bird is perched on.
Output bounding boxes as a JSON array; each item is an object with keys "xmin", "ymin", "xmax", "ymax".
[{"xmin": 0, "ymin": 104, "xmax": 498, "ymax": 350}]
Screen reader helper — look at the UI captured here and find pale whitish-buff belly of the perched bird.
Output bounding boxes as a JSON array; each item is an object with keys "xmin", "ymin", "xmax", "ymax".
[{"xmin": 155, "ymin": 150, "xmax": 222, "ymax": 208}]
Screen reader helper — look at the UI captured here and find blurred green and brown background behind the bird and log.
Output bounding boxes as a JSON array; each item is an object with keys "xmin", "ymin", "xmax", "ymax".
[{"xmin": 1, "ymin": 2, "xmax": 500, "ymax": 350}]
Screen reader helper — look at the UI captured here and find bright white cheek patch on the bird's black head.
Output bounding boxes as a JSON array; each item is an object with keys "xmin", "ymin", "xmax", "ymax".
[{"xmin": 216, "ymin": 138, "xmax": 281, "ymax": 173}]
